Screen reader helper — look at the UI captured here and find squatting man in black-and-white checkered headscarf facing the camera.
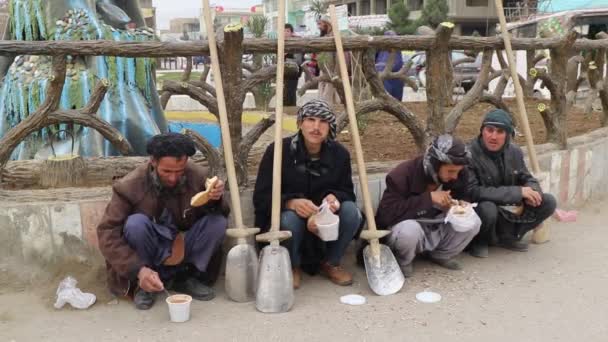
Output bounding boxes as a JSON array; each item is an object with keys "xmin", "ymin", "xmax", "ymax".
[{"xmin": 253, "ymin": 100, "xmax": 361, "ymax": 288}]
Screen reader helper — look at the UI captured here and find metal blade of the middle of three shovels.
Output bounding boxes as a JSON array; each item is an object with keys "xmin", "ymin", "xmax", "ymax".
[{"xmin": 255, "ymin": 245, "xmax": 294, "ymax": 313}]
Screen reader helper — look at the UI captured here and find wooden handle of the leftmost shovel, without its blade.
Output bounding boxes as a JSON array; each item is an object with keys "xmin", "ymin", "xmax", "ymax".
[{"xmin": 203, "ymin": 0, "xmax": 244, "ymax": 228}]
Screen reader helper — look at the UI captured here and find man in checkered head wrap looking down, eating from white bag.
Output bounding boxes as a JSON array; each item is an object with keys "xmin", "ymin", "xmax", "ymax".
[{"xmin": 376, "ymin": 135, "xmax": 479, "ymax": 277}]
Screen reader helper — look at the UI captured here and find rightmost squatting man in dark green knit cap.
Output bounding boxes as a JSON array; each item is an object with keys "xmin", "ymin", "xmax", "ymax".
[{"xmin": 470, "ymin": 109, "xmax": 556, "ymax": 257}]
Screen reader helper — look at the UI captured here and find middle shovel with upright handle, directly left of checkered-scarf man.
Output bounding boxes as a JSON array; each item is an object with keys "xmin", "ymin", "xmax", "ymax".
[{"xmin": 255, "ymin": 0, "xmax": 294, "ymax": 313}]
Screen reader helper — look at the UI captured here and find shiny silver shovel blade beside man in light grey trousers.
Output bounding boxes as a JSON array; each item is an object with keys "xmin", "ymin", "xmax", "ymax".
[{"xmin": 363, "ymin": 245, "xmax": 405, "ymax": 296}]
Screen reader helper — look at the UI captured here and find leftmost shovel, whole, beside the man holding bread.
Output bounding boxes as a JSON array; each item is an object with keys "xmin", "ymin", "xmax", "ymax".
[{"xmin": 203, "ymin": 0, "xmax": 260, "ymax": 302}]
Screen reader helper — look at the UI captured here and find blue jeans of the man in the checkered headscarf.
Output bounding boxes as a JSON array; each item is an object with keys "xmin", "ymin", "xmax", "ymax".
[{"xmin": 281, "ymin": 201, "xmax": 362, "ymax": 267}]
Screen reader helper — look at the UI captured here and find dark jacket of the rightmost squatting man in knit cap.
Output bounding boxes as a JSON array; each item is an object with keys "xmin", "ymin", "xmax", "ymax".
[{"xmin": 469, "ymin": 138, "xmax": 542, "ymax": 205}]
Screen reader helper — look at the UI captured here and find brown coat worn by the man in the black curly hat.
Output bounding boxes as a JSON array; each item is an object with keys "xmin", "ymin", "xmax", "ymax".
[{"xmin": 97, "ymin": 162, "xmax": 228, "ymax": 296}]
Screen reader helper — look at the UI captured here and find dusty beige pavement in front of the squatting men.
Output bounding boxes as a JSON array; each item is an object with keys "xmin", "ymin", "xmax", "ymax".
[{"xmin": 0, "ymin": 202, "xmax": 608, "ymax": 342}]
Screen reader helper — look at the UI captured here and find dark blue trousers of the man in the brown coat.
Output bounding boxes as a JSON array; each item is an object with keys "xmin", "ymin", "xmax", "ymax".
[{"xmin": 124, "ymin": 214, "xmax": 228, "ymax": 281}]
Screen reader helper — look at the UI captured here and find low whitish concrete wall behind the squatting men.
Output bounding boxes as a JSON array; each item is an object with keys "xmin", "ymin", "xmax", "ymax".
[{"xmin": 0, "ymin": 128, "xmax": 608, "ymax": 259}]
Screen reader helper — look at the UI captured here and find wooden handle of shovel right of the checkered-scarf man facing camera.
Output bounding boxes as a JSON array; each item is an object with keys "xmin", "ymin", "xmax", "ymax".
[{"xmin": 329, "ymin": 5, "xmax": 377, "ymax": 232}]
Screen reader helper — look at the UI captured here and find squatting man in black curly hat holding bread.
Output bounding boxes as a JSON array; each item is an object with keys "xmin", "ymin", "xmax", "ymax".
[{"xmin": 97, "ymin": 133, "xmax": 228, "ymax": 310}]
